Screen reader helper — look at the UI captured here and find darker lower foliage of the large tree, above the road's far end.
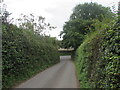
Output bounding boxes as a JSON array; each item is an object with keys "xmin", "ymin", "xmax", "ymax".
[{"xmin": 61, "ymin": 19, "xmax": 94, "ymax": 49}]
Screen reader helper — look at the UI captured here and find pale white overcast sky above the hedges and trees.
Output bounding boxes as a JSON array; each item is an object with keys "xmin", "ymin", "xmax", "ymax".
[{"xmin": 0, "ymin": 0, "xmax": 120, "ymax": 40}]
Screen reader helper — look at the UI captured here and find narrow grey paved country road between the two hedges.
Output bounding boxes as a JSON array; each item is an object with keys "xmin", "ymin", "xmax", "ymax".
[{"xmin": 16, "ymin": 56, "xmax": 78, "ymax": 88}]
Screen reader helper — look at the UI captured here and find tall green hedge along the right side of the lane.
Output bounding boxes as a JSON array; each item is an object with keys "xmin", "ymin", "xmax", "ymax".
[{"xmin": 75, "ymin": 24, "xmax": 120, "ymax": 88}]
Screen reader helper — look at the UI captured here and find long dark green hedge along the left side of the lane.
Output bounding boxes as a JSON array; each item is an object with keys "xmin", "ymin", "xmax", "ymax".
[{"xmin": 2, "ymin": 25, "xmax": 59, "ymax": 88}]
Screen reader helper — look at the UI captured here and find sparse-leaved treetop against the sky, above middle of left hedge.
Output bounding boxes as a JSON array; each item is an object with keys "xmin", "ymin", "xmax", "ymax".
[{"xmin": 18, "ymin": 14, "xmax": 56, "ymax": 34}]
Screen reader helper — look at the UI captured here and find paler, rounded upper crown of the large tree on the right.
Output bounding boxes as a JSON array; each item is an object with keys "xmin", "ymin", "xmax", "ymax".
[{"xmin": 70, "ymin": 3, "xmax": 114, "ymax": 21}]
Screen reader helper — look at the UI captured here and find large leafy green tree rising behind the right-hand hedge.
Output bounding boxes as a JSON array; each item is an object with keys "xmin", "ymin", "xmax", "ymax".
[{"xmin": 60, "ymin": 3, "xmax": 114, "ymax": 49}]
